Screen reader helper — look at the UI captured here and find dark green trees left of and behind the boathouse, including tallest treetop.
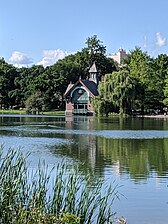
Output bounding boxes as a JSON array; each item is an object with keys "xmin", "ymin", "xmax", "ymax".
[{"xmin": 0, "ymin": 35, "xmax": 116, "ymax": 113}]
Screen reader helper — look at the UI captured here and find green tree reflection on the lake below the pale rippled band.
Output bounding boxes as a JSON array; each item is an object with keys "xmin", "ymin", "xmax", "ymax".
[{"xmin": 50, "ymin": 135, "xmax": 168, "ymax": 181}]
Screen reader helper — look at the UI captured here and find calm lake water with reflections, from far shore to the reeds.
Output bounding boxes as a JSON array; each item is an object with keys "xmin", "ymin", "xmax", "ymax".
[{"xmin": 0, "ymin": 115, "xmax": 168, "ymax": 224}]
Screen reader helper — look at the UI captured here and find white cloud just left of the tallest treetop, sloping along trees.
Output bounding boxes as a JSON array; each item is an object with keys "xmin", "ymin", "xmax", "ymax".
[{"xmin": 37, "ymin": 49, "xmax": 70, "ymax": 67}]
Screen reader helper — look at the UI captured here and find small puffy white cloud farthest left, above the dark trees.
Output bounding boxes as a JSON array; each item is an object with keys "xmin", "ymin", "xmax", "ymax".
[{"xmin": 9, "ymin": 51, "xmax": 33, "ymax": 67}]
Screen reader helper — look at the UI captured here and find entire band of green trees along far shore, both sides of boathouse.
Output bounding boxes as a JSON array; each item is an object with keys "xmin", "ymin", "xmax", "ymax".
[{"xmin": 0, "ymin": 35, "xmax": 168, "ymax": 115}]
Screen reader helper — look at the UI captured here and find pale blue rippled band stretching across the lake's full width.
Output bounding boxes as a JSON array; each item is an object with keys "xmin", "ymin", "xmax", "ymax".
[{"xmin": 1, "ymin": 126, "xmax": 168, "ymax": 139}]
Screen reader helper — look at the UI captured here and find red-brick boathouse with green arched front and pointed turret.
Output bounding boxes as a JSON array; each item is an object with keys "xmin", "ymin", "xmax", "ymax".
[{"xmin": 64, "ymin": 63, "xmax": 98, "ymax": 115}]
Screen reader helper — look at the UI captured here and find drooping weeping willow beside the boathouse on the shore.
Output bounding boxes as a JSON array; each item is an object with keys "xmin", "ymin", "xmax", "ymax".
[{"xmin": 94, "ymin": 69, "xmax": 137, "ymax": 115}]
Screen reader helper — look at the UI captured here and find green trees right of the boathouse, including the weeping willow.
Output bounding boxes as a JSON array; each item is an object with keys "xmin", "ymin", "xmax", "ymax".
[{"xmin": 93, "ymin": 47, "xmax": 168, "ymax": 115}]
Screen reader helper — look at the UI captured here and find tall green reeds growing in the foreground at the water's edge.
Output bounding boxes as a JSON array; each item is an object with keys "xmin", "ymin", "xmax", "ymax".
[{"xmin": 0, "ymin": 147, "xmax": 118, "ymax": 224}]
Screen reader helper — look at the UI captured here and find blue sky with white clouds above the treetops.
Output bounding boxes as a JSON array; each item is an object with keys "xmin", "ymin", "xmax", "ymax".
[{"xmin": 0, "ymin": 0, "xmax": 168, "ymax": 67}]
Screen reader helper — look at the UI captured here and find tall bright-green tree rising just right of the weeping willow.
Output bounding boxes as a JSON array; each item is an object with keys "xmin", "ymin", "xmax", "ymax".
[{"xmin": 124, "ymin": 47, "xmax": 154, "ymax": 113}]
